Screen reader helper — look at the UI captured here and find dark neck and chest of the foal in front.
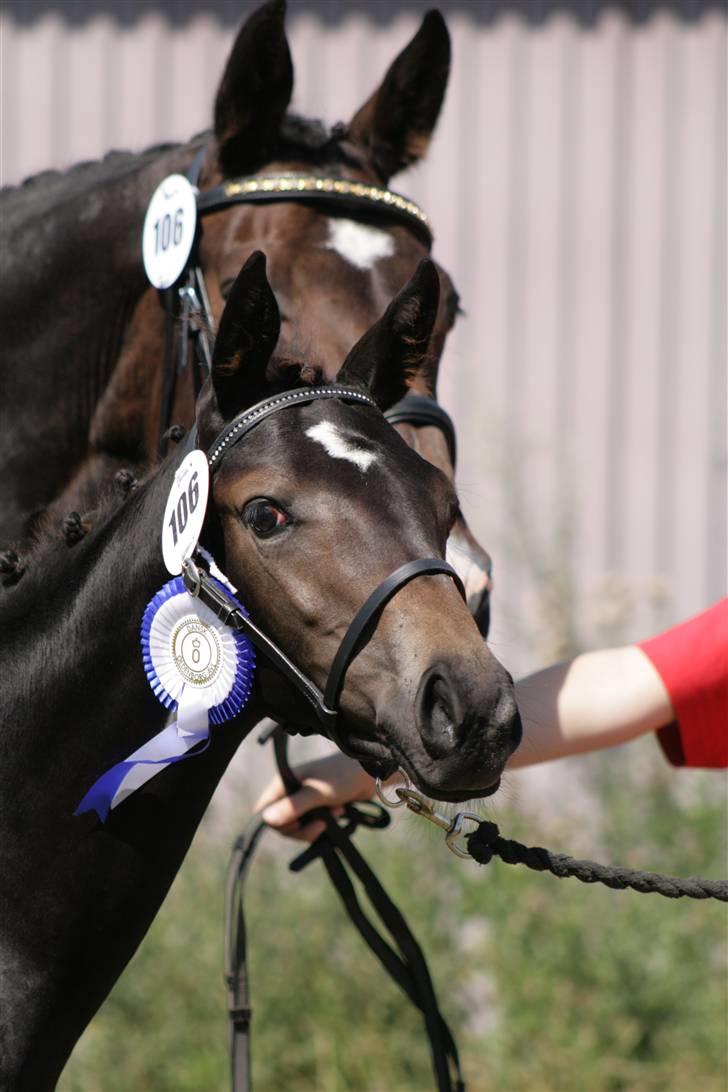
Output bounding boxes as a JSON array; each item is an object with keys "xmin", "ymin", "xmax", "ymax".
[{"xmin": 0, "ymin": 438, "xmax": 261, "ymax": 1088}]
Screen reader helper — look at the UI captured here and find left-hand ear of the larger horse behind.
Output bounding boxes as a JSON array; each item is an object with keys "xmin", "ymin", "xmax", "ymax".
[{"xmin": 215, "ymin": 0, "xmax": 294, "ymax": 176}]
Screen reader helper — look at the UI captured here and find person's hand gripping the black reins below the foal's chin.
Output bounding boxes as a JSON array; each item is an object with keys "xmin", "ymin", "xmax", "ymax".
[{"xmin": 254, "ymin": 751, "xmax": 374, "ymax": 842}]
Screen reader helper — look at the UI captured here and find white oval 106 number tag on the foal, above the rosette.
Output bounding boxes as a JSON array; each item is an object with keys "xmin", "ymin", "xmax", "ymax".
[{"xmin": 162, "ymin": 451, "xmax": 210, "ymax": 577}]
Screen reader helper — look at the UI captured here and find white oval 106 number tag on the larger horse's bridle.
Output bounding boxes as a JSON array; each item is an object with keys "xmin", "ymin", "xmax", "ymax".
[{"xmin": 142, "ymin": 175, "xmax": 198, "ymax": 288}]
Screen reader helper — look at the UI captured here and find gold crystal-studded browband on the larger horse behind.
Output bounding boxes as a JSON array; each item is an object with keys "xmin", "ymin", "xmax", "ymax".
[{"xmin": 198, "ymin": 175, "xmax": 432, "ymax": 244}]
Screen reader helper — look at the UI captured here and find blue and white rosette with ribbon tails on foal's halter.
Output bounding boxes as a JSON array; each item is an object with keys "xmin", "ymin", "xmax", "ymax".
[{"xmin": 75, "ymin": 577, "xmax": 255, "ymax": 821}]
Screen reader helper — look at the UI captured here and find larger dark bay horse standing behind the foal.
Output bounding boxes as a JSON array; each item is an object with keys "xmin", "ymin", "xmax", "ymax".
[{"xmin": 0, "ymin": 0, "xmax": 489, "ymax": 613}]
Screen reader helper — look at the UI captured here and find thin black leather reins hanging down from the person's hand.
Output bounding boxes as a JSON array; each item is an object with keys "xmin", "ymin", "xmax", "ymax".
[{"xmin": 225, "ymin": 727, "xmax": 465, "ymax": 1092}]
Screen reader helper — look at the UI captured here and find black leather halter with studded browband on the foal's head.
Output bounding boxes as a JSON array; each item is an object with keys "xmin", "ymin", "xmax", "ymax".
[{"xmin": 182, "ymin": 387, "xmax": 465, "ymax": 747}]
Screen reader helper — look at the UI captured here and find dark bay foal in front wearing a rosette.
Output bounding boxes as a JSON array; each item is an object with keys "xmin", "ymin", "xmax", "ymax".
[{"xmin": 0, "ymin": 253, "xmax": 521, "ymax": 1092}]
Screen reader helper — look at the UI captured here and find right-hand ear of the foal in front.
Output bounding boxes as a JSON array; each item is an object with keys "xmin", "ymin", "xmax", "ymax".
[{"xmin": 336, "ymin": 258, "xmax": 440, "ymax": 410}]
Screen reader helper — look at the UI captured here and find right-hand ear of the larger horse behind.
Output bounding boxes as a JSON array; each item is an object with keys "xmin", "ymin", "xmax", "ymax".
[{"xmin": 349, "ymin": 11, "xmax": 450, "ymax": 182}]
